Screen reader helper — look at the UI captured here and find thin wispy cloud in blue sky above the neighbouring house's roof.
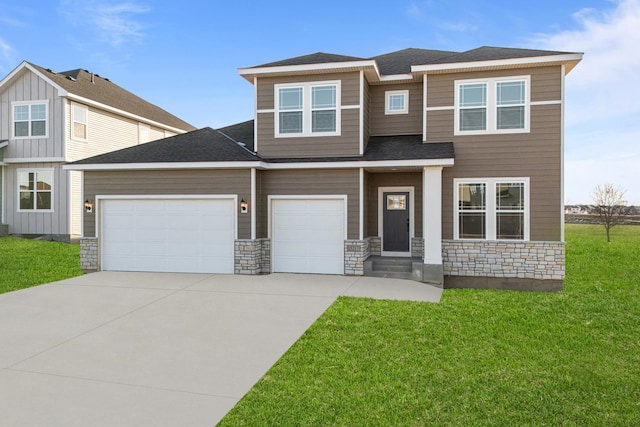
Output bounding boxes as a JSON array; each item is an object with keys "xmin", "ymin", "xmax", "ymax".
[{"xmin": 60, "ymin": 0, "xmax": 150, "ymax": 47}]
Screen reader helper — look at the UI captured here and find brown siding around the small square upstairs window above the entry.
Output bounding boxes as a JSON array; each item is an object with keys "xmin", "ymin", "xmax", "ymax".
[{"xmin": 369, "ymin": 83, "xmax": 423, "ymax": 136}]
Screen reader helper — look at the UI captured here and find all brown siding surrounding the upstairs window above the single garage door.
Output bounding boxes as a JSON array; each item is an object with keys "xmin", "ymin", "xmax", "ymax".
[{"xmin": 256, "ymin": 72, "xmax": 360, "ymax": 158}]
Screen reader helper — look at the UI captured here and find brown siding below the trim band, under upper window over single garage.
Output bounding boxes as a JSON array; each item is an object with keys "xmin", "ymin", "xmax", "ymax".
[{"xmin": 258, "ymin": 109, "xmax": 360, "ymax": 158}]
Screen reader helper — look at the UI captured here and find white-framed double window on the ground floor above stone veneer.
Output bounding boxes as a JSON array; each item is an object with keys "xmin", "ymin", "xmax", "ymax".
[{"xmin": 453, "ymin": 178, "xmax": 529, "ymax": 240}]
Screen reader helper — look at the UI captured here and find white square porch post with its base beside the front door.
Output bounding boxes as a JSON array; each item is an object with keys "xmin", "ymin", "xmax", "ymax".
[{"xmin": 422, "ymin": 167, "xmax": 444, "ymax": 285}]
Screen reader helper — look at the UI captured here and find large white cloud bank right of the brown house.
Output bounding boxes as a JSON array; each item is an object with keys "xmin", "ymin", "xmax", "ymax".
[{"xmin": 532, "ymin": 0, "xmax": 640, "ymax": 205}]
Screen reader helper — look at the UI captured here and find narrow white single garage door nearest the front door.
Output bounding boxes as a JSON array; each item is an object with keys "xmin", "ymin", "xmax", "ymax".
[{"xmin": 271, "ymin": 199, "xmax": 346, "ymax": 274}]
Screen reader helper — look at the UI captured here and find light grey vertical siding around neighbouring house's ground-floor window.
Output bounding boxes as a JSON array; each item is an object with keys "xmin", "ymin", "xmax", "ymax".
[{"xmin": 4, "ymin": 162, "xmax": 71, "ymax": 235}]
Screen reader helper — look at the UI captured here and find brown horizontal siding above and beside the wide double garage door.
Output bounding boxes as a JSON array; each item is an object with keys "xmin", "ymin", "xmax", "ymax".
[{"xmin": 84, "ymin": 170, "xmax": 251, "ymax": 239}]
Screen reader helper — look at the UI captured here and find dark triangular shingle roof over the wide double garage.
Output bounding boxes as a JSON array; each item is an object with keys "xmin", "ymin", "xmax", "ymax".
[{"xmin": 72, "ymin": 127, "xmax": 260, "ymax": 165}]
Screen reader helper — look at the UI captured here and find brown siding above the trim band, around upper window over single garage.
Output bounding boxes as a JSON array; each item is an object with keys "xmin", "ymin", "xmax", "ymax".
[{"xmin": 256, "ymin": 72, "xmax": 360, "ymax": 110}]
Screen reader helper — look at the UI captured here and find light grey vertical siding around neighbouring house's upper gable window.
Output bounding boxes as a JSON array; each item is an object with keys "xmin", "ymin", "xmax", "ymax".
[{"xmin": 0, "ymin": 71, "xmax": 65, "ymax": 161}]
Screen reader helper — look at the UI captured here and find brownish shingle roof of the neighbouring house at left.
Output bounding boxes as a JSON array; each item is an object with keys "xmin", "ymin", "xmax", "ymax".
[{"xmin": 29, "ymin": 63, "xmax": 195, "ymax": 131}]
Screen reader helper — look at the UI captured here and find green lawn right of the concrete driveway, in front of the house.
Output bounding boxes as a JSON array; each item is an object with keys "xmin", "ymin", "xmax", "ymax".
[{"xmin": 220, "ymin": 225, "xmax": 640, "ymax": 426}]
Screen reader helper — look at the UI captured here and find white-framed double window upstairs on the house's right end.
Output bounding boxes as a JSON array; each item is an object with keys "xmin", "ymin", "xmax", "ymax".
[{"xmin": 454, "ymin": 76, "xmax": 531, "ymax": 135}]
